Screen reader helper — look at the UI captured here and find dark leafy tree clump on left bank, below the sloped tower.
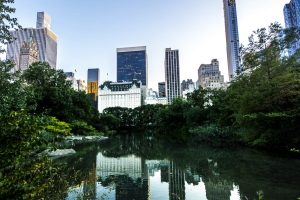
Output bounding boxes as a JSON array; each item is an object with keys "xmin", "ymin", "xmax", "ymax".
[{"xmin": 22, "ymin": 62, "xmax": 99, "ymax": 125}]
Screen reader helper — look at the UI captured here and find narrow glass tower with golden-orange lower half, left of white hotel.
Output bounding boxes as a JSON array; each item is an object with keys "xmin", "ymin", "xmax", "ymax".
[{"xmin": 87, "ymin": 68, "xmax": 100, "ymax": 108}]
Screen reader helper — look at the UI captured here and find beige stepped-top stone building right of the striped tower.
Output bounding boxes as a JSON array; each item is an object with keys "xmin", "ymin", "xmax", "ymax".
[{"xmin": 198, "ymin": 59, "xmax": 225, "ymax": 89}]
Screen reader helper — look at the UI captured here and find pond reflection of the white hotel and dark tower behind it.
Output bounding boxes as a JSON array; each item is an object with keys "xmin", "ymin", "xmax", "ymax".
[{"xmin": 97, "ymin": 153, "xmax": 150, "ymax": 200}]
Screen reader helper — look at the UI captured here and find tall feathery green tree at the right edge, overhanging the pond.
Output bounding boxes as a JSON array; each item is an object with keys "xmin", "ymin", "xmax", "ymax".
[{"xmin": 227, "ymin": 23, "xmax": 300, "ymax": 149}]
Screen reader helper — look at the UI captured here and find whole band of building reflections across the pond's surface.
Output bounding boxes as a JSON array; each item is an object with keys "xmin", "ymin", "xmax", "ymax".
[{"xmin": 67, "ymin": 153, "xmax": 237, "ymax": 200}]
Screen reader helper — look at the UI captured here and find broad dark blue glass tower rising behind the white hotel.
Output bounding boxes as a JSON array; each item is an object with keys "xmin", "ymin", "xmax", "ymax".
[{"xmin": 117, "ymin": 46, "xmax": 148, "ymax": 86}]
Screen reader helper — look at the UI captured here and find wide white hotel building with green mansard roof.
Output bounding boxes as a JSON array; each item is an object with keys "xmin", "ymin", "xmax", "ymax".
[{"xmin": 98, "ymin": 80, "xmax": 143, "ymax": 112}]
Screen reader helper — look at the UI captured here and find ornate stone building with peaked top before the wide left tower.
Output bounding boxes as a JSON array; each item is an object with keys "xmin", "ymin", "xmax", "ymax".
[{"xmin": 16, "ymin": 37, "xmax": 38, "ymax": 71}]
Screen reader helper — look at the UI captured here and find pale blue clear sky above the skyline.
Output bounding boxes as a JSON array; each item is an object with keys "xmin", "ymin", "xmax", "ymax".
[{"xmin": 6, "ymin": 0, "xmax": 289, "ymax": 90}]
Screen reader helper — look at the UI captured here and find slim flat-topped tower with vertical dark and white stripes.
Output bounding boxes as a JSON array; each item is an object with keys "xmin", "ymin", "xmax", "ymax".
[{"xmin": 165, "ymin": 48, "xmax": 180, "ymax": 103}]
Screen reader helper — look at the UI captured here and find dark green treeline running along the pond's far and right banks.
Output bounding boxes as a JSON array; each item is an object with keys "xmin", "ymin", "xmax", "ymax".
[{"xmin": 101, "ymin": 23, "xmax": 300, "ymax": 150}]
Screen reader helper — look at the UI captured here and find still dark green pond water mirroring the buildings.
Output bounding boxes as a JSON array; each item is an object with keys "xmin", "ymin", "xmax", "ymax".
[{"xmin": 57, "ymin": 136, "xmax": 300, "ymax": 200}]
